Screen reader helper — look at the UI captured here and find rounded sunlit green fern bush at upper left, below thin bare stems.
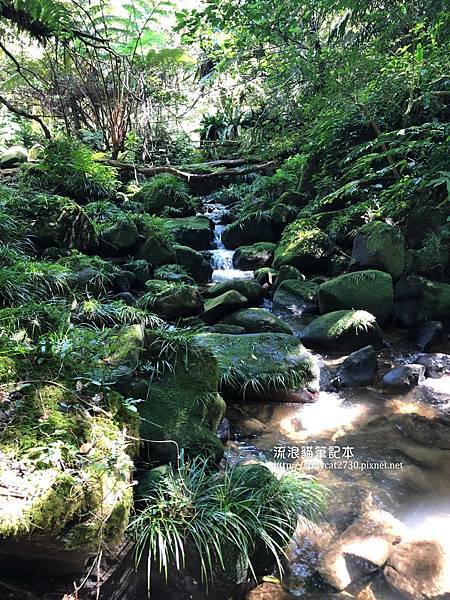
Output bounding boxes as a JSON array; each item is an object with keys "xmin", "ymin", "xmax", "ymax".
[{"xmin": 26, "ymin": 138, "xmax": 118, "ymax": 202}]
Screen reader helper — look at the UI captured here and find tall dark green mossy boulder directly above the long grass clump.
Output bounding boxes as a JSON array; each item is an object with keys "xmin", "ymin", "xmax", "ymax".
[{"xmin": 138, "ymin": 346, "xmax": 225, "ymax": 462}]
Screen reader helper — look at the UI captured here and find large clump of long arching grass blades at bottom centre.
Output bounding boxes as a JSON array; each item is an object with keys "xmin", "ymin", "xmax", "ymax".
[{"xmin": 131, "ymin": 459, "xmax": 326, "ymax": 586}]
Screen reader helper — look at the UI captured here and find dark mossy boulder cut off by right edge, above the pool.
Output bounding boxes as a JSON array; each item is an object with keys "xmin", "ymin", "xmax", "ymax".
[{"xmin": 395, "ymin": 275, "xmax": 450, "ymax": 327}]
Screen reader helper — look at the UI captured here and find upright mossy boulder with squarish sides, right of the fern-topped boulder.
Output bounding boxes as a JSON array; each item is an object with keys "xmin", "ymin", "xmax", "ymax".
[{"xmin": 352, "ymin": 221, "xmax": 406, "ymax": 279}]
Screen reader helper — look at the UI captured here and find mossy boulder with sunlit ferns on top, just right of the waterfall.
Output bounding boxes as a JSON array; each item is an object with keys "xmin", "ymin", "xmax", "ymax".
[{"xmin": 273, "ymin": 219, "xmax": 333, "ymax": 273}]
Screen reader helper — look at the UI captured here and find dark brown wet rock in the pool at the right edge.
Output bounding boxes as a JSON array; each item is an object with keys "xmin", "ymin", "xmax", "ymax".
[{"xmin": 396, "ymin": 414, "xmax": 450, "ymax": 450}]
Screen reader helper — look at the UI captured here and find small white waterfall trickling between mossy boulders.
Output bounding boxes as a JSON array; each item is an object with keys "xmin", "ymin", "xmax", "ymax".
[{"xmin": 204, "ymin": 202, "xmax": 253, "ymax": 281}]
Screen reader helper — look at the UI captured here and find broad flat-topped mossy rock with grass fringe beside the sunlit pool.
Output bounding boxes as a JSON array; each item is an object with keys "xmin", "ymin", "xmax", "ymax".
[{"xmin": 196, "ymin": 333, "xmax": 319, "ymax": 401}]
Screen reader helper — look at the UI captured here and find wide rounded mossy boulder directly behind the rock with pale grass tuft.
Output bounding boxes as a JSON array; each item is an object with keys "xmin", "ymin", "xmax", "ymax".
[{"xmin": 318, "ymin": 270, "xmax": 394, "ymax": 324}]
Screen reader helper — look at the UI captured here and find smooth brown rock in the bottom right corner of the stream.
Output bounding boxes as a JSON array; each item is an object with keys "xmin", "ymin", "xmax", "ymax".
[{"xmin": 384, "ymin": 539, "xmax": 450, "ymax": 600}]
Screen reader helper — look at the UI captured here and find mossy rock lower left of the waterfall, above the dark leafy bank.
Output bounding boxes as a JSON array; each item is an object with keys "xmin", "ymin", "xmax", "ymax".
[{"xmin": 137, "ymin": 279, "xmax": 203, "ymax": 321}]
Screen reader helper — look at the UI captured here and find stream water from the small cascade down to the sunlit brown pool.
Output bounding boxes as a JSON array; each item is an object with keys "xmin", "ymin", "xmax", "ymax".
[{"xmin": 205, "ymin": 199, "xmax": 450, "ymax": 600}]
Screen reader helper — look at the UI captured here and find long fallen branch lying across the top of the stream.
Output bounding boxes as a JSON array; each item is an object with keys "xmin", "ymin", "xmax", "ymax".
[{"xmin": 101, "ymin": 158, "xmax": 277, "ymax": 182}]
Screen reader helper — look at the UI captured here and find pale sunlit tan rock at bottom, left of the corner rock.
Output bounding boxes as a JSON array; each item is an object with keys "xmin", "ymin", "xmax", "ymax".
[{"xmin": 318, "ymin": 510, "xmax": 406, "ymax": 590}]
